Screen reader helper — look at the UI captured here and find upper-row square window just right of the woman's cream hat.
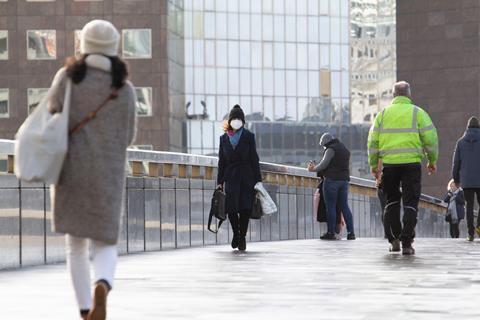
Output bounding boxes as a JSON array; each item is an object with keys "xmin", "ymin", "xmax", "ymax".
[{"xmin": 122, "ymin": 29, "xmax": 152, "ymax": 59}]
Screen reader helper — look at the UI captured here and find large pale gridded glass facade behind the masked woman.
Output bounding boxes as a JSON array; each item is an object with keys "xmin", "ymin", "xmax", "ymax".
[{"xmin": 184, "ymin": 0, "xmax": 351, "ymax": 164}]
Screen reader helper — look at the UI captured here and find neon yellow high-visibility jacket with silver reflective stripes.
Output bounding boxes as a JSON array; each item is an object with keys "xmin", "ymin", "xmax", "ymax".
[{"xmin": 368, "ymin": 96, "xmax": 438, "ymax": 168}]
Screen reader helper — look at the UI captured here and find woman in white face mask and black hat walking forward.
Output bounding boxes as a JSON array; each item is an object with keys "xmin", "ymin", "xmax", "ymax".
[{"xmin": 217, "ymin": 105, "xmax": 262, "ymax": 251}]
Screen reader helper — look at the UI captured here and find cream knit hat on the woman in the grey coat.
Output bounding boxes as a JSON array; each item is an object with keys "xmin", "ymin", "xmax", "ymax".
[{"xmin": 80, "ymin": 20, "xmax": 120, "ymax": 57}]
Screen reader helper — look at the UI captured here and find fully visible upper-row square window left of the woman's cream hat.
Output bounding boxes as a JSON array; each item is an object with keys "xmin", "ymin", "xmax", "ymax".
[{"xmin": 27, "ymin": 30, "xmax": 57, "ymax": 60}]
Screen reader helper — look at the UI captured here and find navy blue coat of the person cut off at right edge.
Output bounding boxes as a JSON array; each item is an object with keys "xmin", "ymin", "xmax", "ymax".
[{"xmin": 452, "ymin": 128, "xmax": 480, "ymax": 189}]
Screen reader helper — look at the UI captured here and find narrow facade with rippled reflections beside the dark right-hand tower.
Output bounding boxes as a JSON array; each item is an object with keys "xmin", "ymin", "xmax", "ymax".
[{"xmin": 350, "ymin": 0, "xmax": 397, "ymax": 123}]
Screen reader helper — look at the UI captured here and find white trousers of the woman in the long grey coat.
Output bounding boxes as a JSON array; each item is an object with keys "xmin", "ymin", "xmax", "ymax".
[{"xmin": 65, "ymin": 234, "xmax": 117, "ymax": 310}]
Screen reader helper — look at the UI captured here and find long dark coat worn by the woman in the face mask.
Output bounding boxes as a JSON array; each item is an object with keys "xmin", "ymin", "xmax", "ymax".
[{"xmin": 217, "ymin": 128, "xmax": 262, "ymax": 213}]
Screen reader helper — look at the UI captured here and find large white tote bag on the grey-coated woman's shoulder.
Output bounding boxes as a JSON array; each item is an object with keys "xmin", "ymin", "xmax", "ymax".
[{"xmin": 14, "ymin": 79, "xmax": 72, "ymax": 185}]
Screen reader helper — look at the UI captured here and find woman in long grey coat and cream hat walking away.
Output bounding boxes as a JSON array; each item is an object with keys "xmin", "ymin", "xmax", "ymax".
[{"xmin": 48, "ymin": 20, "xmax": 136, "ymax": 320}]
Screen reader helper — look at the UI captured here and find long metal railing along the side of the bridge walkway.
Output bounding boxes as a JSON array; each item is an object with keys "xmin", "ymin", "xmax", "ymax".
[{"xmin": 0, "ymin": 140, "xmax": 447, "ymax": 269}]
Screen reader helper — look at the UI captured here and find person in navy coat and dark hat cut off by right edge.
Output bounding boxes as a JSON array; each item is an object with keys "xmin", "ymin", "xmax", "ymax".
[{"xmin": 452, "ymin": 117, "xmax": 480, "ymax": 241}]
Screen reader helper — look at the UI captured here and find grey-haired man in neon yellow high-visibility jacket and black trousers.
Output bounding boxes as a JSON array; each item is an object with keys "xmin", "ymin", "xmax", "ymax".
[{"xmin": 368, "ymin": 81, "xmax": 438, "ymax": 255}]
